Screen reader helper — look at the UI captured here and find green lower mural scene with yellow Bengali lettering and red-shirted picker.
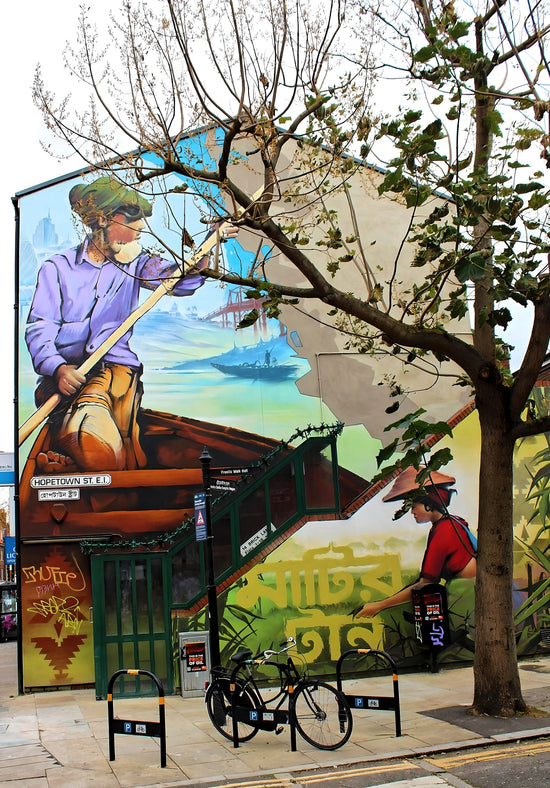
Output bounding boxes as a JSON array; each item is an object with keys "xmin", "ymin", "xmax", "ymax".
[{"xmin": 183, "ymin": 404, "xmax": 550, "ymax": 674}]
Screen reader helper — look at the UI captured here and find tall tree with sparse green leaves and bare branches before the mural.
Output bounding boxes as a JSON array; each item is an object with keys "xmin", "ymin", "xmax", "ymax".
[{"xmin": 34, "ymin": 0, "xmax": 550, "ymax": 715}]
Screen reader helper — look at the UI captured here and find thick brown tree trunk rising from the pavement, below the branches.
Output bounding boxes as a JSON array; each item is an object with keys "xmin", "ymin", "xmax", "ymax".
[{"xmin": 473, "ymin": 384, "xmax": 526, "ymax": 717}]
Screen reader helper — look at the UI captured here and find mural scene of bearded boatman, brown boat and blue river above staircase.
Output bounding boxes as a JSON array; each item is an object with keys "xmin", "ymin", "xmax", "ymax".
[{"xmin": 19, "ymin": 165, "xmax": 332, "ymax": 686}]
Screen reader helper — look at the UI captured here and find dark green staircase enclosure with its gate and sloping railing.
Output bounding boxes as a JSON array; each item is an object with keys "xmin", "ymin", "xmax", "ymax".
[{"xmin": 87, "ymin": 430, "xmax": 341, "ymax": 697}]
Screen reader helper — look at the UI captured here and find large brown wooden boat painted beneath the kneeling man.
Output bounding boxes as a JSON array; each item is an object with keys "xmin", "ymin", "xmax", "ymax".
[{"xmin": 19, "ymin": 409, "xmax": 366, "ymax": 539}]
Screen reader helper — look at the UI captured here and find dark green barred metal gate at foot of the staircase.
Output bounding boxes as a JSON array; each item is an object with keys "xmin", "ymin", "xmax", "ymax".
[{"xmin": 92, "ymin": 553, "xmax": 173, "ymax": 698}]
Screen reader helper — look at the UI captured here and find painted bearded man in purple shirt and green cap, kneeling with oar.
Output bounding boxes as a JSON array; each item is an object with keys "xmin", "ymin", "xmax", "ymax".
[{"xmin": 25, "ymin": 176, "xmax": 204, "ymax": 472}]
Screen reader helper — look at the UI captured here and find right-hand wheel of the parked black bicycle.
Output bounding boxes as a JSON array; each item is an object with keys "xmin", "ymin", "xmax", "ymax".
[{"xmin": 294, "ymin": 680, "xmax": 353, "ymax": 750}]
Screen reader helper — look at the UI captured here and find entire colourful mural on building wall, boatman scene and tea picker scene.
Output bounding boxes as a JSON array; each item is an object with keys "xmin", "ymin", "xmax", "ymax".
[{"xmin": 18, "ymin": 139, "xmax": 550, "ymax": 686}]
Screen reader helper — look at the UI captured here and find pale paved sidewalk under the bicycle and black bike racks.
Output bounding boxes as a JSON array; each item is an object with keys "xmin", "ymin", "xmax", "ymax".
[{"xmin": 0, "ymin": 642, "xmax": 550, "ymax": 788}]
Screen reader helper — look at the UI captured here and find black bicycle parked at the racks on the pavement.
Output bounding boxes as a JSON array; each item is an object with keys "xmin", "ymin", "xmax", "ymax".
[{"xmin": 205, "ymin": 637, "xmax": 353, "ymax": 750}]
